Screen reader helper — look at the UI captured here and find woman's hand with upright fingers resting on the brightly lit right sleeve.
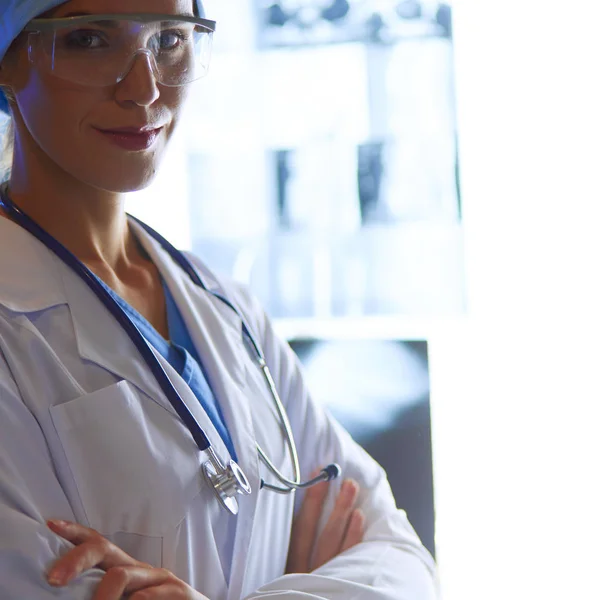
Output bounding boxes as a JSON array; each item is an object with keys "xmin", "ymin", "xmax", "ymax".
[{"xmin": 286, "ymin": 472, "xmax": 365, "ymax": 573}]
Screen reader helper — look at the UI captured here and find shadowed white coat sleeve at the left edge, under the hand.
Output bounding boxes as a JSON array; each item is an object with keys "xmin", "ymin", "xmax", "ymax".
[{"xmin": 0, "ymin": 352, "xmax": 104, "ymax": 600}]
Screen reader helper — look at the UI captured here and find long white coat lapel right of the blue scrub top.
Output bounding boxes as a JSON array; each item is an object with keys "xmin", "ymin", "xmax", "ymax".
[{"xmin": 132, "ymin": 225, "xmax": 260, "ymax": 598}]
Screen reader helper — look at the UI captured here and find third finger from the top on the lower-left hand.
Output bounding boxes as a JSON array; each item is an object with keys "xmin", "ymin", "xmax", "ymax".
[{"xmin": 92, "ymin": 566, "xmax": 174, "ymax": 600}]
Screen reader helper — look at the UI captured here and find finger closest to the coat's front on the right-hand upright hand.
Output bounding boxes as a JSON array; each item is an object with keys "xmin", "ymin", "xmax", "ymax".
[{"xmin": 287, "ymin": 471, "xmax": 329, "ymax": 573}]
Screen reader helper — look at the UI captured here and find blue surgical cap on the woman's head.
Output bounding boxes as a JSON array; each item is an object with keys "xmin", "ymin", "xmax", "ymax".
[{"xmin": 0, "ymin": 0, "xmax": 205, "ymax": 113}]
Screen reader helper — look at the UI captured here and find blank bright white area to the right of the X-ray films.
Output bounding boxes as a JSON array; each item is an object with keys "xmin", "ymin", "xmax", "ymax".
[{"xmin": 431, "ymin": 0, "xmax": 591, "ymax": 600}]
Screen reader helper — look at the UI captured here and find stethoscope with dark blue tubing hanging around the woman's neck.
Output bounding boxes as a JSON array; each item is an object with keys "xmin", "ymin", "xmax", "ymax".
[{"xmin": 0, "ymin": 183, "xmax": 341, "ymax": 515}]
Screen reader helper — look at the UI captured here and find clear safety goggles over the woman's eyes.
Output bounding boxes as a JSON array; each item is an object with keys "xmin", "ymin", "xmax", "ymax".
[{"xmin": 24, "ymin": 14, "xmax": 216, "ymax": 87}]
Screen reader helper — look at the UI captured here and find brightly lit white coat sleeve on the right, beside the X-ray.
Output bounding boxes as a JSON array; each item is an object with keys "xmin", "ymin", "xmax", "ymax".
[{"xmin": 229, "ymin": 288, "xmax": 439, "ymax": 600}]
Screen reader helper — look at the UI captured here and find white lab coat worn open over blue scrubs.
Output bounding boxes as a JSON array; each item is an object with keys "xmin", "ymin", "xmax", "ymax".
[{"xmin": 0, "ymin": 213, "xmax": 437, "ymax": 600}]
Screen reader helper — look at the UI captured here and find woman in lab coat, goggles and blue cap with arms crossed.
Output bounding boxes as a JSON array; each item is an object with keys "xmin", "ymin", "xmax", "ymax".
[{"xmin": 0, "ymin": 0, "xmax": 436, "ymax": 600}]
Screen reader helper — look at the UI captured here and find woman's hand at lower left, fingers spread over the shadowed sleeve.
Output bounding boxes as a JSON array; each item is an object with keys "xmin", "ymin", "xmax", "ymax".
[{"xmin": 47, "ymin": 521, "xmax": 207, "ymax": 600}]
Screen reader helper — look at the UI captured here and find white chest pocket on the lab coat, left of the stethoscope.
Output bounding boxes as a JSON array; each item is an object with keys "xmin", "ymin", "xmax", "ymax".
[{"xmin": 51, "ymin": 381, "xmax": 208, "ymax": 541}]
